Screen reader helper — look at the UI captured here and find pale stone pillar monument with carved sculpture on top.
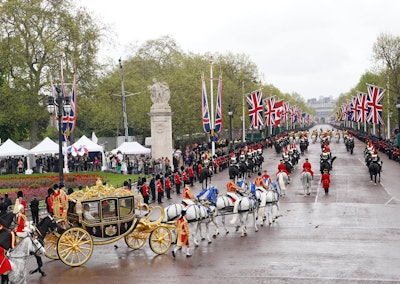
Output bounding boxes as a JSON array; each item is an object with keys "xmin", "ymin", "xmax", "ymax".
[{"xmin": 148, "ymin": 79, "xmax": 172, "ymax": 164}]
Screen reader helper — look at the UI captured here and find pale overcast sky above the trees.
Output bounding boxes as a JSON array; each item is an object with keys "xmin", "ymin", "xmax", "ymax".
[{"xmin": 78, "ymin": 0, "xmax": 400, "ymax": 99}]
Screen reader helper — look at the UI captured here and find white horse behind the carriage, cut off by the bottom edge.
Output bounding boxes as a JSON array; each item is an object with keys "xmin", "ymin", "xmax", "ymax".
[{"xmin": 3, "ymin": 233, "xmax": 45, "ymax": 284}]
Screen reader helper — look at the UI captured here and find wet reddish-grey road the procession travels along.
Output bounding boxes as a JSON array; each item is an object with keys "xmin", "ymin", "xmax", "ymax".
[{"xmin": 28, "ymin": 126, "xmax": 400, "ymax": 284}]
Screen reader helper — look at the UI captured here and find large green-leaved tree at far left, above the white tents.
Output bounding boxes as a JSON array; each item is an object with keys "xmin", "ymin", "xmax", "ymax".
[{"xmin": 0, "ymin": 0, "xmax": 102, "ymax": 146}]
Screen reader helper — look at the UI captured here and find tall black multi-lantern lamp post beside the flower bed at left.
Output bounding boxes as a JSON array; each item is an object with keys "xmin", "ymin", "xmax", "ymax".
[{"xmin": 47, "ymin": 86, "xmax": 71, "ymax": 183}]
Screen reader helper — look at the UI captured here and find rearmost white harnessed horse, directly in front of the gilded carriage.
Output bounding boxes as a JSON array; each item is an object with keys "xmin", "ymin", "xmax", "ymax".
[{"xmin": 163, "ymin": 200, "xmax": 218, "ymax": 246}]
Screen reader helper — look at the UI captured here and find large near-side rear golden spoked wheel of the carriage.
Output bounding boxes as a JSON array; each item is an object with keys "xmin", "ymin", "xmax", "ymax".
[{"xmin": 57, "ymin": 228, "xmax": 93, "ymax": 266}]
